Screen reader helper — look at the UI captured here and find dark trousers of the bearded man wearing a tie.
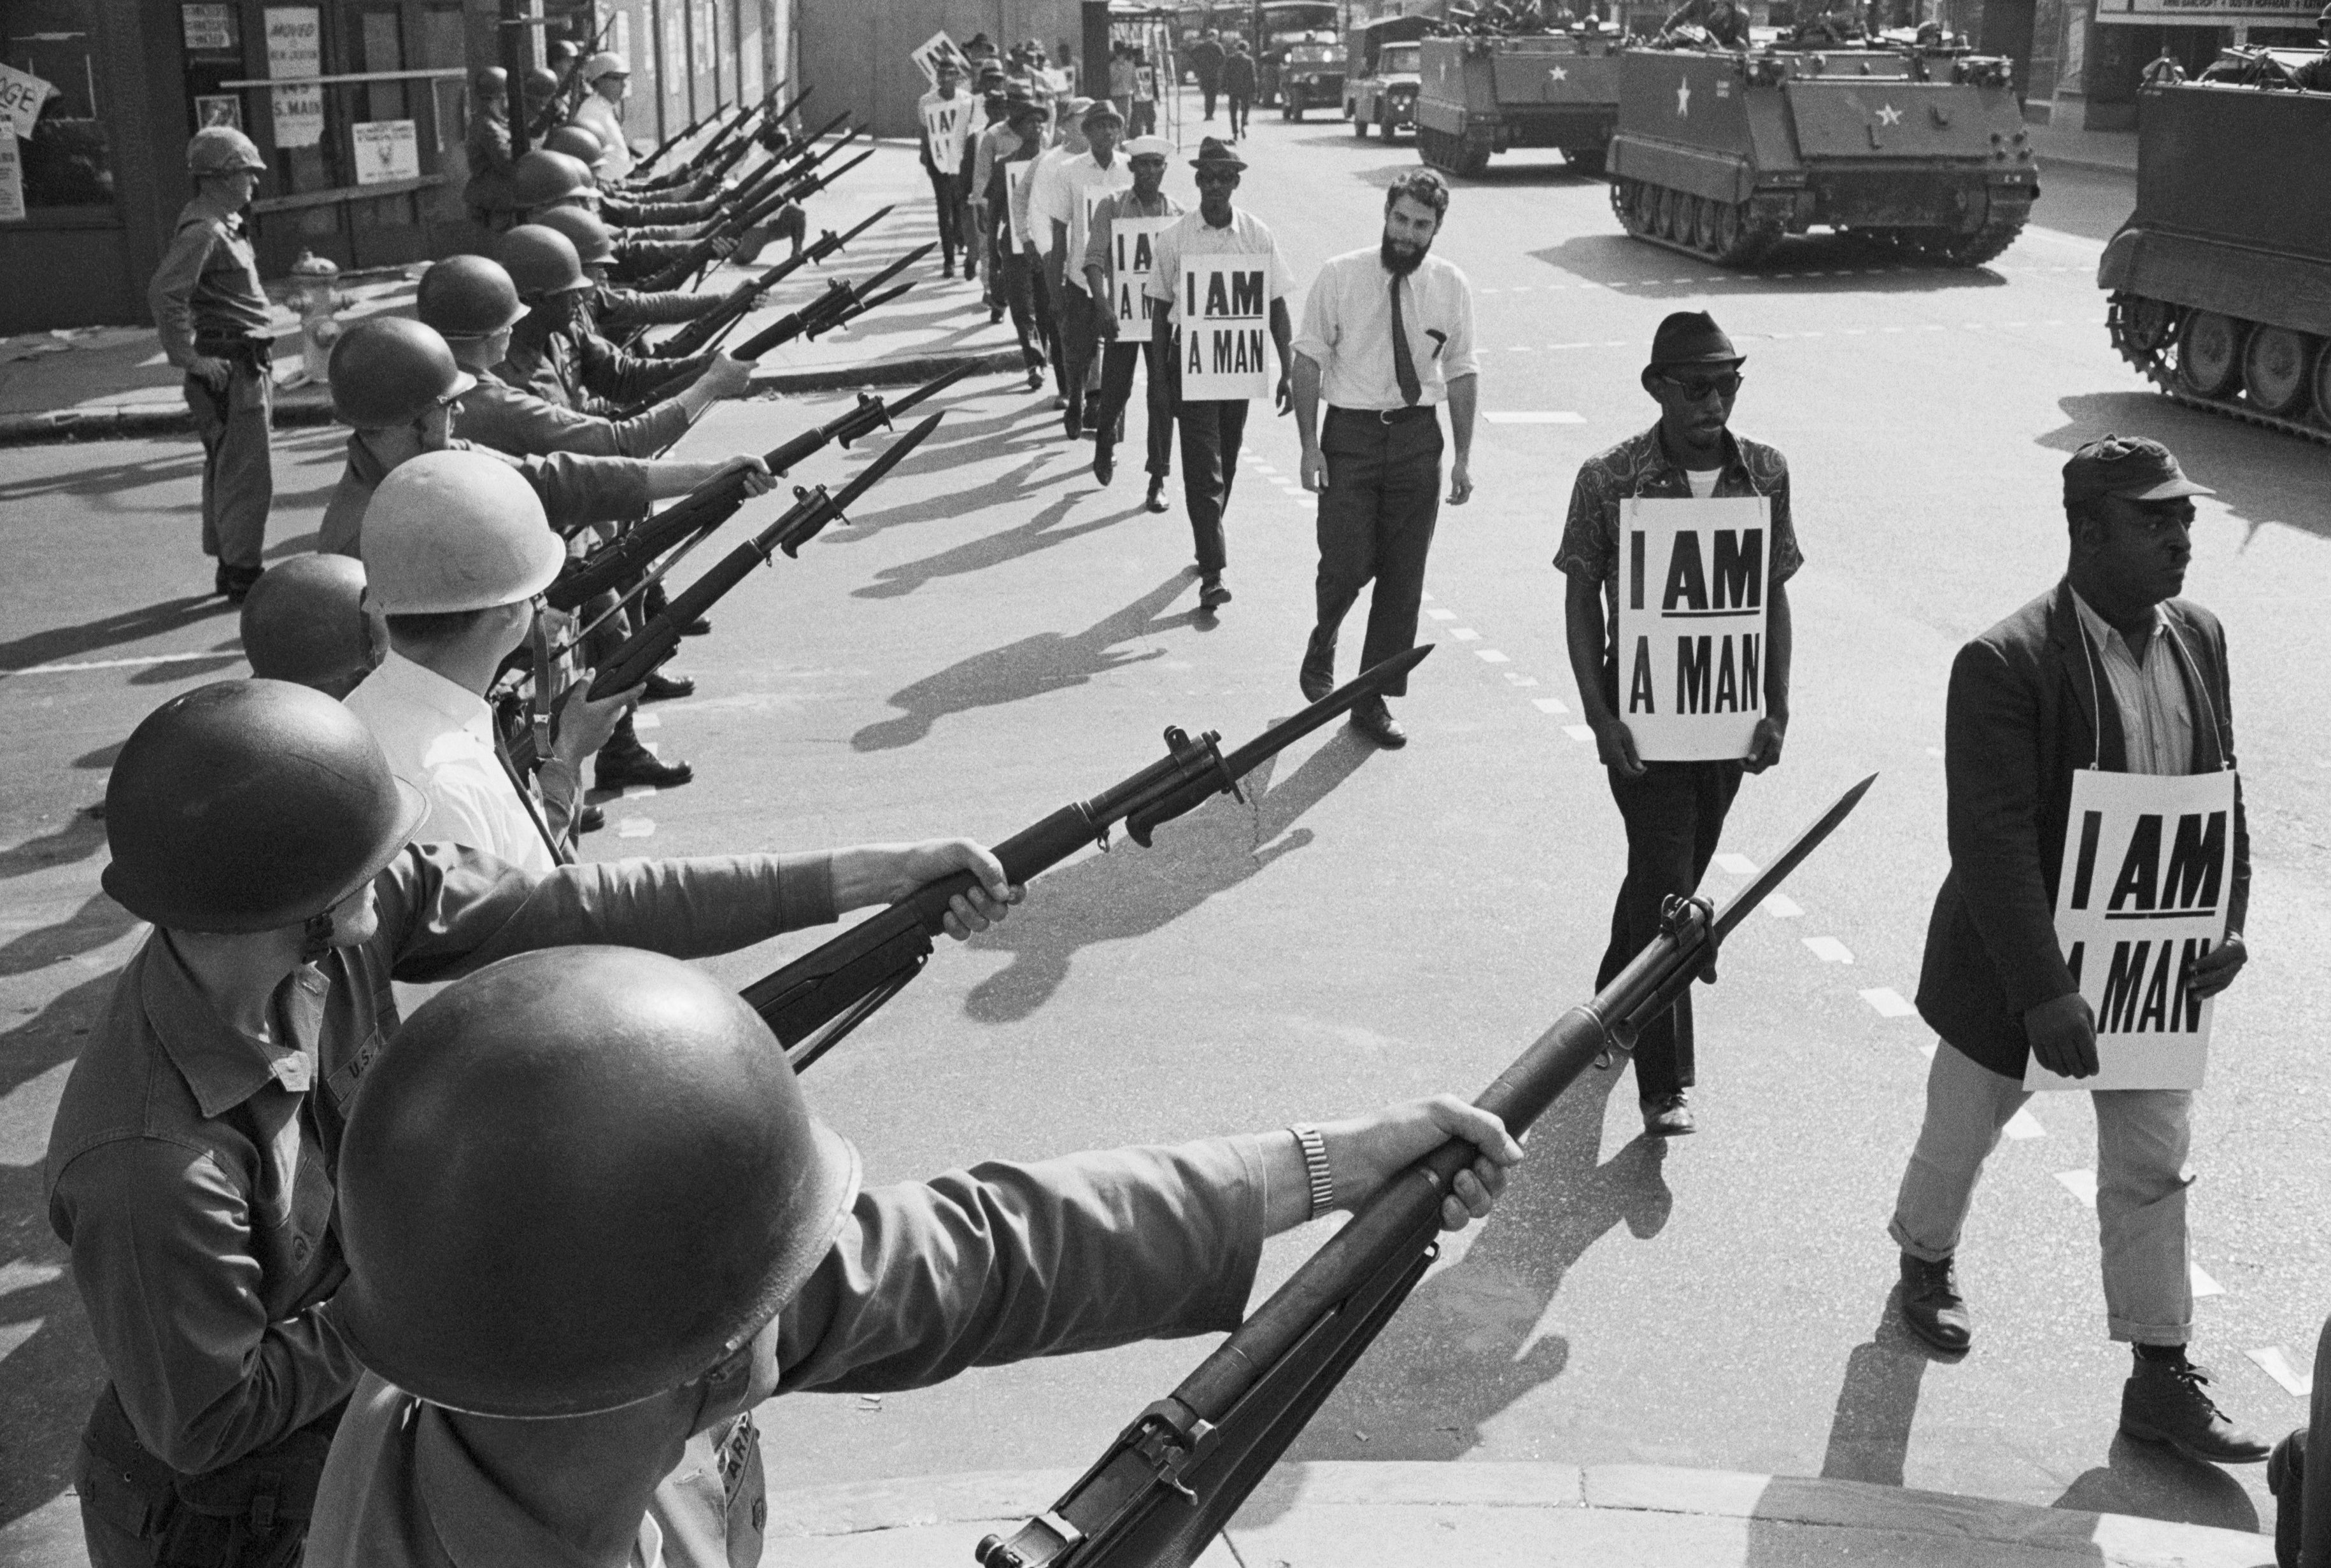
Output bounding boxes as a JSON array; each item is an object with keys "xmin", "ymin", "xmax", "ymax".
[{"xmin": 1303, "ymin": 407, "xmax": 1440, "ymax": 696}]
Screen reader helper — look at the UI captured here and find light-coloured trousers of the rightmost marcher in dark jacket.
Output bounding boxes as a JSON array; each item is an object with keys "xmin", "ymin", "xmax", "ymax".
[{"xmin": 1888, "ymin": 1042, "xmax": 2193, "ymax": 1345}]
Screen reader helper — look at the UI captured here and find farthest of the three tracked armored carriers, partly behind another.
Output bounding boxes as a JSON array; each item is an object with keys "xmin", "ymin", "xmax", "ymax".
[{"xmin": 1417, "ymin": 32, "xmax": 1620, "ymax": 174}]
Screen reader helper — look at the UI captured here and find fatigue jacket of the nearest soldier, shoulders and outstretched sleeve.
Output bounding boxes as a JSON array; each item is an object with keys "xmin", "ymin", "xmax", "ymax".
[{"xmin": 306, "ymin": 1137, "xmax": 1266, "ymax": 1568}]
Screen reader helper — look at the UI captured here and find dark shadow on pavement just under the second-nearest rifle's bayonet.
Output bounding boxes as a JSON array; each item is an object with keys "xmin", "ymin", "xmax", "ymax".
[{"xmin": 963, "ymin": 727, "xmax": 1375, "ymax": 1023}]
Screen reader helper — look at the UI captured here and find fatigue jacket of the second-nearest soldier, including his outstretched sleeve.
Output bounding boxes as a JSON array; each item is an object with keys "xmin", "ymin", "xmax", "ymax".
[{"xmin": 42, "ymin": 844, "xmax": 835, "ymax": 1473}]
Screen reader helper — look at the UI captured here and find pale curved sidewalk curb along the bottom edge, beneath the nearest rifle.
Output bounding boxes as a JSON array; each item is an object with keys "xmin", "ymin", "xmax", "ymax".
[{"xmin": 767, "ymin": 1461, "xmax": 2272, "ymax": 1568}]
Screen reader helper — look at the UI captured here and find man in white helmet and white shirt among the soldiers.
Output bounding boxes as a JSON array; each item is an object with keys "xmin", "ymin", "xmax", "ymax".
[{"xmin": 345, "ymin": 452, "xmax": 639, "ymax": 873}]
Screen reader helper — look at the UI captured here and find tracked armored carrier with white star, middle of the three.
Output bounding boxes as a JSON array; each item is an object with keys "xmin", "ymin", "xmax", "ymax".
[{"xmin": 1611, "ymin": 46, "xmax": 2039, "ymax": 268}]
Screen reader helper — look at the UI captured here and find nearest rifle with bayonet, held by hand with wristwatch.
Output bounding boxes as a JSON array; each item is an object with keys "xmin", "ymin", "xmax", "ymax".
[{"xmin": 977, "ymin": 773, "xmax": 1876, "ymax": 1568}]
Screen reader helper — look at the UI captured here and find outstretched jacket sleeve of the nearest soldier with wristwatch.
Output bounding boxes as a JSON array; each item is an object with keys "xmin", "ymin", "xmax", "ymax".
[{"xmin": 779, "ymin": 1137, "xmax": 1266, "ymax": 1394}]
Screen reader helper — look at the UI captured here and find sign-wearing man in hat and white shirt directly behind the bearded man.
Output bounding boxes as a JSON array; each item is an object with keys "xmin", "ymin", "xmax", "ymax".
[{"xmin": 1149, "ymin": 138, "xmax": 1296, "ymax": 611}]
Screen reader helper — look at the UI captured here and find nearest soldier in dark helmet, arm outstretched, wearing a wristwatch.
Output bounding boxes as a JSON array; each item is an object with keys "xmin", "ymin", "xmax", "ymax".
[{"xmin": 308, "ymin": 949, "xmax": 1522, "ymax": 1568}]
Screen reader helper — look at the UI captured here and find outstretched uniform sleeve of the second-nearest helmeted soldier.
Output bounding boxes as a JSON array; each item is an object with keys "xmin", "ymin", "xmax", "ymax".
[{"xmin": 373, "ymin": 844, "xmax": 837, "ymax": 983}]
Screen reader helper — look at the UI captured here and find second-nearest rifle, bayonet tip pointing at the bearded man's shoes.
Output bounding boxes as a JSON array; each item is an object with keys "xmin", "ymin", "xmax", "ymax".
[{"xmin": 744, "ymin": 643, "xmax": 1434, "ymax": 1071}]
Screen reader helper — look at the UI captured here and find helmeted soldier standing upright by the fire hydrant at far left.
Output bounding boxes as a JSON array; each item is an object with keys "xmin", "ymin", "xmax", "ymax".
[{"xmin": 147, "ymin": 126, "xmax": 275, "ymax": 604}]
